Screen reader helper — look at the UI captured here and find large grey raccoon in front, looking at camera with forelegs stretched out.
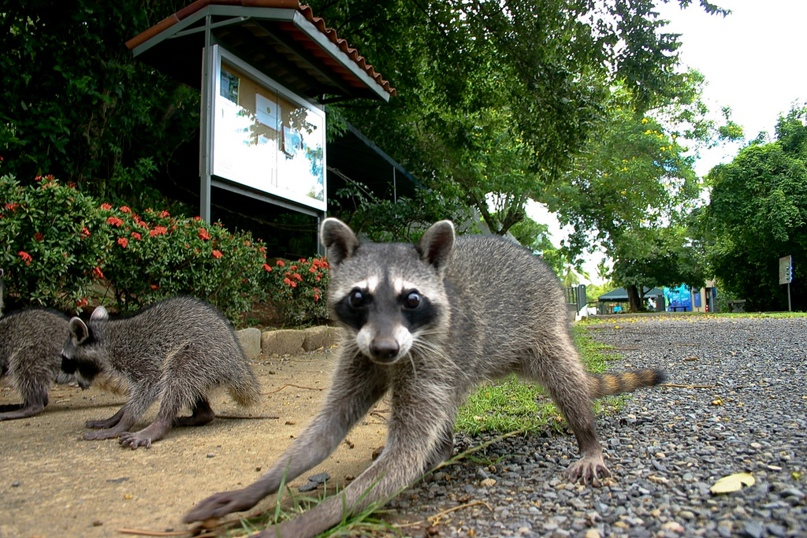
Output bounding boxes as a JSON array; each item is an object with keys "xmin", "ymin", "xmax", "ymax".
[{"xmin": 185, "ymin": 219, "xmax": 663, "ymax": 538}]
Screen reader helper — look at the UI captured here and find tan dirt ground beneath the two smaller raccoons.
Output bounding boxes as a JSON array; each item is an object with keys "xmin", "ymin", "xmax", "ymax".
[{"xmin": 0, "ymin": 351, "xmax": 386, "ymax": 538}]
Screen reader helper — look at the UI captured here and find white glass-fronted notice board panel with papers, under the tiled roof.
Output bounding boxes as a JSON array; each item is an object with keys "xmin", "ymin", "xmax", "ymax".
[{"xmin": 213, "ymin": 59, "xmax": 326, "ymax": 211}]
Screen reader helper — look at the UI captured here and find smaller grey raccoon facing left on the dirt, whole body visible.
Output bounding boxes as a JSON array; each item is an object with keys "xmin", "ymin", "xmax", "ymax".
[{"xmin": 62, "ymin": 297, "xmax": 260, "ymax": 448}]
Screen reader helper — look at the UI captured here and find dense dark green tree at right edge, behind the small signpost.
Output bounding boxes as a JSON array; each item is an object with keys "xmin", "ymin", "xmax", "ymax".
[{"xmin": 701, "ymin": 106, "xmax": 807, "ymax": 310}]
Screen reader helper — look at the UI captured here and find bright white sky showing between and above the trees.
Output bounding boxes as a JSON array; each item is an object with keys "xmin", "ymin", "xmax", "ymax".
[{"xmin": 527, "ymin": 0, "xmax": 807, "ymax": 283}]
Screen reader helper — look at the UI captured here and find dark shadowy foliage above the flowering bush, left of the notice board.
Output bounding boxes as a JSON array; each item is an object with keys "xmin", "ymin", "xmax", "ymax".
[{"xmin": 0, "ymin": 0, "xmax": 199, "ymax": 204}]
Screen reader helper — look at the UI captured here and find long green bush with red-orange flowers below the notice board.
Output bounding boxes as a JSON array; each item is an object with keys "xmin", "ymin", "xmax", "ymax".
[{"xmin": 0, "ymin": 172, "xmax": 328, "ymax": 326}]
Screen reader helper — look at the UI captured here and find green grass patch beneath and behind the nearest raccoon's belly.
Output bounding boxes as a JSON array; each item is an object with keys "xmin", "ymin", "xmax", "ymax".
[{"xmin": 455, "ymin": 325, "xmax": 627, "ymax": 435}]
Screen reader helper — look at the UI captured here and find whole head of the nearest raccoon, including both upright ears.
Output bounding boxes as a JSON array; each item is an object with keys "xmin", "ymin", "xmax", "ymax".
[{"xmin": 320, "ymin": 218, "xmax": 454, "ymax": 364}]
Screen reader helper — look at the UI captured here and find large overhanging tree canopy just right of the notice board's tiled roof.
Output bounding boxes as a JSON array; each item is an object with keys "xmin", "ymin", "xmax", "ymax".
[{"xmin": 311, "ymin": 0, "xmax": 726, "ymax": 234}]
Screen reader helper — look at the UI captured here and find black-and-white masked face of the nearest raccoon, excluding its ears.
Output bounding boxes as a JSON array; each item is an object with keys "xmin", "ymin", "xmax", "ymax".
[{"xmin": 334, "ymin": 279, "xmax": 440, "ymax": 364}]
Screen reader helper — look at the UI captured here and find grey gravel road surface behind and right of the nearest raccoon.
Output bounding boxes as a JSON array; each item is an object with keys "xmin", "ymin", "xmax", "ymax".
[{"xmin": 389, "ymin": 316, "xmax": 807, "ymax": 538}]
